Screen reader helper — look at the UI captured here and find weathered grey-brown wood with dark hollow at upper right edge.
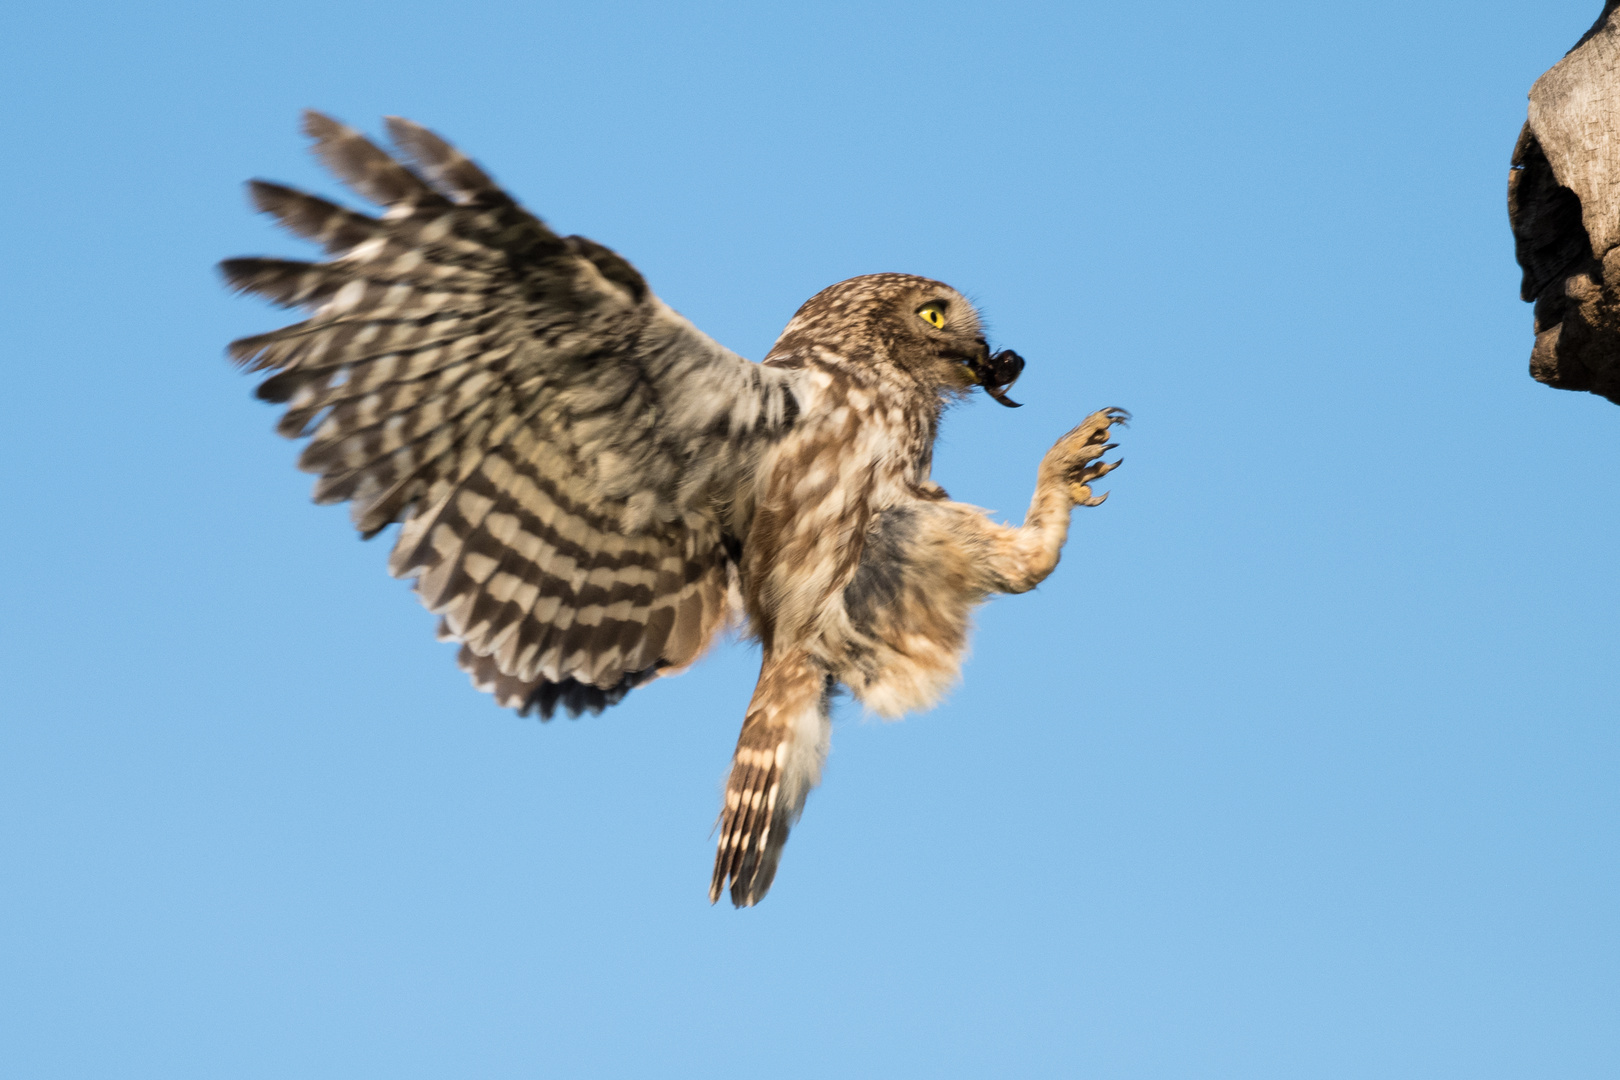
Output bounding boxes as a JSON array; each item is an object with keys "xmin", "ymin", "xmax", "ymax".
[{"xmin": 1508, "ymin": 0, "xmax": 1620, "ymax": 405}]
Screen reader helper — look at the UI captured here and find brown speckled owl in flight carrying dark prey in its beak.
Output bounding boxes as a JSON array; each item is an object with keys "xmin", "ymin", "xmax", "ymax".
[{"xmin": 220, "ymin": 113, "xmax": 1126, "ymax": 907}]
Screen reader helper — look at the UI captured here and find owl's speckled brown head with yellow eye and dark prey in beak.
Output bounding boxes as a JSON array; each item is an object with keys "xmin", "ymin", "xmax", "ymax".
[{"xmin": 766, "ymin": 274, "xmax": 1024, "ymax": 408}]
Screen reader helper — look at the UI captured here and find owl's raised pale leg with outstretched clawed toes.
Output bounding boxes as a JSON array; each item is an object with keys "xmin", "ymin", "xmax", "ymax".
[{"xmin": 985, "ymin": 408, "xmax": 1131, "ymax": 593}]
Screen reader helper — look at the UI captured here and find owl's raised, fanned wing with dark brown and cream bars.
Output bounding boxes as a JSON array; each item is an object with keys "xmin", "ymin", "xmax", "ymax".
[{"xmin": 222, "ymin": 113, "xmax": 799, "ymax": 717}]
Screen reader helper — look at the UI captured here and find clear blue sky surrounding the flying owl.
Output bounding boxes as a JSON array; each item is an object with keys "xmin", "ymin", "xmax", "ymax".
[{"xmin": 0, "ymin": 0, "xmax": 1620, "ymax": 1080}]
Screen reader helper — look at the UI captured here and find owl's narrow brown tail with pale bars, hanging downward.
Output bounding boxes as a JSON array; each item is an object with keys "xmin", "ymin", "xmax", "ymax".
[{"xmin": 710, "ymin": 651, "xmax": 831, "ymax": 907}]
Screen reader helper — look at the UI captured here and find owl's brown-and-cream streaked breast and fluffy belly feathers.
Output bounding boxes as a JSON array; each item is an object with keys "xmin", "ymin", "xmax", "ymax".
[{"xmin": 740, "ymin": 350, "xmax": 982, "ymax": 716}]
